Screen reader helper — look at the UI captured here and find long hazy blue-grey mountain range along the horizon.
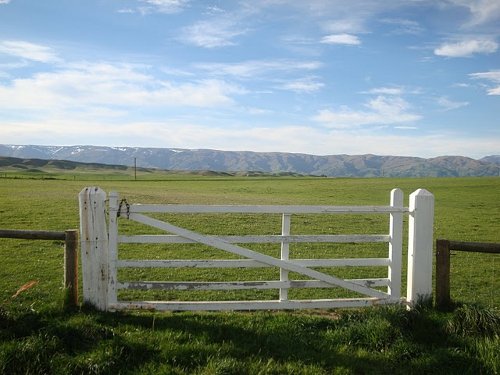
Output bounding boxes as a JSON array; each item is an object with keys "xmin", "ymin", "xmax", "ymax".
[{"xmin": 0, "ymin": 145, "xmax": 500, "ymax": 177}]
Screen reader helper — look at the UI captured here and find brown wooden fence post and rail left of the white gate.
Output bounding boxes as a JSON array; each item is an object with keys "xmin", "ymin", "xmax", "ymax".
[{"xmin": 0, "ymin": 229, "xmax": 78, "ymax": 307}]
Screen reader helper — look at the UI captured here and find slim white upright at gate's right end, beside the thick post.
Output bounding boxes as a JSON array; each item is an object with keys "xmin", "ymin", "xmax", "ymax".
[{"xmin": 388, "ymin": 189, "xmax": 403, "ymax": 301}]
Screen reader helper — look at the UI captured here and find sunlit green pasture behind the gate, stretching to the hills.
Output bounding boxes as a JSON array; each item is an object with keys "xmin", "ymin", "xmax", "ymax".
[{"xmin": 0, "ymin": 175, "xmax": 500, "ymax": 306}]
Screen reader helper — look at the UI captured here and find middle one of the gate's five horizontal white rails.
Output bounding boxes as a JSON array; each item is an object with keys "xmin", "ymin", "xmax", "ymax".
[{"xmin": 117, "ymin": 258, "xmax": 391, "ymax": 268}]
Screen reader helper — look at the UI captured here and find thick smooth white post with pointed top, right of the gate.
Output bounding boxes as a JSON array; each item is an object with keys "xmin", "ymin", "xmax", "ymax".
[{"xmin": 406, "ymin": 189, "xmax": 434, "ymax": 306}]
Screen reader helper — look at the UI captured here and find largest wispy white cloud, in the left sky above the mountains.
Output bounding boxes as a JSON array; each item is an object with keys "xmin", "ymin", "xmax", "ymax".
[{"xmin": 0, "ymin": 63, "xmax": 243, "ymax": 111}]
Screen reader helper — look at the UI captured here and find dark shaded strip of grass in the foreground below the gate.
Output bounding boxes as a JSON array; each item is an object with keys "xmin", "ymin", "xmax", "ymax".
[{"xmin": 0, "ymin": 307, "xmax": 488, "ymax": 374}]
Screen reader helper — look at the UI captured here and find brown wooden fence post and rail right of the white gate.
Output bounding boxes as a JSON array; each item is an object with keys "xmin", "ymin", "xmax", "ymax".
[{"xmin": 436, "ymin": 239, "xmax": 500, "ymax": 309}]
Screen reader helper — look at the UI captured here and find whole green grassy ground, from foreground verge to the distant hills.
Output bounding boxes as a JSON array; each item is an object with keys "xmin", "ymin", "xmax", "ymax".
[{"xmin": 0, "ymin": 172, "xmax": 500, "ymax": 374}]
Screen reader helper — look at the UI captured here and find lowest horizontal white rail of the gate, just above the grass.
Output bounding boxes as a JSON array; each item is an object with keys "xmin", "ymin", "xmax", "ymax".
[{"xmin": 108, "ymin": 297, "xmax": 394, "ymax": 311}]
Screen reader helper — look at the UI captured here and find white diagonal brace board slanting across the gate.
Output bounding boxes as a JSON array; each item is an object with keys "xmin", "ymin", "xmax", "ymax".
[{"xmin": 130, "ymin": 213, "xmax": 389, "ymax": 299}]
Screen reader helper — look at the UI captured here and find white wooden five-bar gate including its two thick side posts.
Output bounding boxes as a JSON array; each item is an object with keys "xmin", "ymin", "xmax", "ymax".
[{"xmin": 80, "ymin": 187, "xmax": 434, "ymax": 310}]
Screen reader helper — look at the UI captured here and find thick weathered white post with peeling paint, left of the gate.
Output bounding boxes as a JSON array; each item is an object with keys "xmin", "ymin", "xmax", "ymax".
[{"xmin": 79, "ymin": 187, "xmax": 108, "ymax": 310}]
